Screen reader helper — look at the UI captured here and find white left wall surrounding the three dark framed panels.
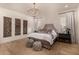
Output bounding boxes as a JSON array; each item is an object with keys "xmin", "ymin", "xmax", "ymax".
[{"xmin": 0, "ymin": 8, "xmax": 34, "ymax": 43}]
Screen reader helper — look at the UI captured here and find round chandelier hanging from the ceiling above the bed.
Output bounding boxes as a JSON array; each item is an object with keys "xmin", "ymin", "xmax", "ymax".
[{"xmin": 27, "ymin": 3, "xmax": 39, "ymax": 18}]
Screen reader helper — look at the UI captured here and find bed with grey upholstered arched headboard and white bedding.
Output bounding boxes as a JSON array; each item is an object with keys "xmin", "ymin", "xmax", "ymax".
[{"xmin": 27, "ymin": 24, "xmax": 58, "ymax": 49}]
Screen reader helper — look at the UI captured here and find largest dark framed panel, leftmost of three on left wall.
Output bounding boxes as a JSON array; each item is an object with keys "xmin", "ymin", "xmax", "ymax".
[{"xmin": 3, "ymin": 16, "xmax": 12, "ymax": 37}]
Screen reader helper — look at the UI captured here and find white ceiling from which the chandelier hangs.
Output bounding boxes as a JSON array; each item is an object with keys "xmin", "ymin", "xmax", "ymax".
[{"xmin": 0, "ymin": 3, "xmax": 79, "ymax": 14}]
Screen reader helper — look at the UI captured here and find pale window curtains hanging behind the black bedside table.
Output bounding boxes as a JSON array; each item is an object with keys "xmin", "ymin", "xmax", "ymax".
[{"xmin": 60, "ymin": 12, "xmax": 76, "ymax": 43}]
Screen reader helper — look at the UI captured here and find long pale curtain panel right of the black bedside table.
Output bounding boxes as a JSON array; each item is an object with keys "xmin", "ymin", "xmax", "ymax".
[{"xmin": 66, "ymin": 12, "xmax": 76, "ymax": 43}]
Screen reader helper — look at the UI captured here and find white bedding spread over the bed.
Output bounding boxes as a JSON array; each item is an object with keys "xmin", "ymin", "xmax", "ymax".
[{"xmin": 27, "ymin": 33, "xmax": 57, "ymax": 45}]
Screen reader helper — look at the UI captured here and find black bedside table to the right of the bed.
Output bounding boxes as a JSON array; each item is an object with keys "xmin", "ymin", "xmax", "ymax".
[{"xmin": 57, "ymin": 33, "xmax": 71, "ymax": 43}]
